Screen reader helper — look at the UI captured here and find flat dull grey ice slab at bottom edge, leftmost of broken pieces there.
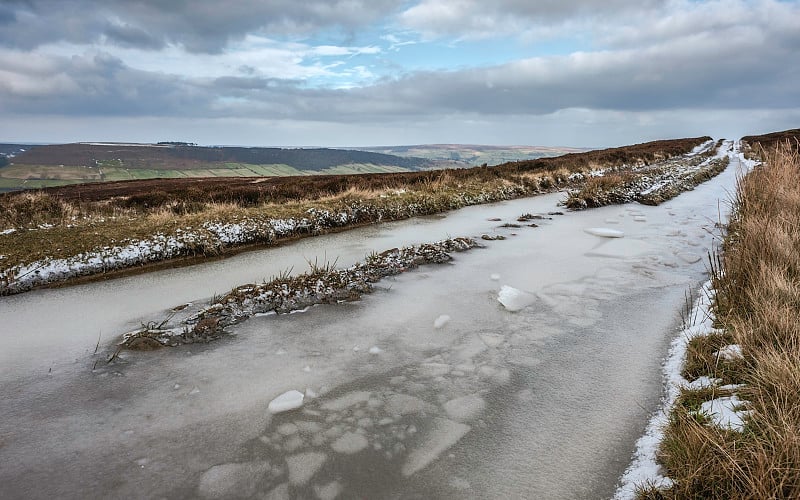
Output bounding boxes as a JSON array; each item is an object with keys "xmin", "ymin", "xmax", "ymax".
[{"xmin": 197, "ymin": 462, "xmax": 270, "ymax": 498}]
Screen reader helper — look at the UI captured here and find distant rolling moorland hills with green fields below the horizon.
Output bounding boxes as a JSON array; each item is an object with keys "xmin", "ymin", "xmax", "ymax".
[{"xmin": 0, "ymin": 142, "xmax": 583, "ymax": 192}]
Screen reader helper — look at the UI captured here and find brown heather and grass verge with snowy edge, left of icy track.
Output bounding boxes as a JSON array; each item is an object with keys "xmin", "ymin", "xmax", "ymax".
[{"xmin": 0, "ymin": 138, "xmax": 720, "ymax": 295}]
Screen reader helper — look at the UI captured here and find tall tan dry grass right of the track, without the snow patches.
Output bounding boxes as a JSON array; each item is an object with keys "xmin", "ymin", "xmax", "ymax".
[{"xmin": 642, "ymin": 146, "xmax": 800, "ymax": 498}]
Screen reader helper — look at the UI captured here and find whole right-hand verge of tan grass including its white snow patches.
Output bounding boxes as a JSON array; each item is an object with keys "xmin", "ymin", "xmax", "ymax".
[{"xmin": 617, "ymin": 140, "xmax": 800, "ymax": 498}]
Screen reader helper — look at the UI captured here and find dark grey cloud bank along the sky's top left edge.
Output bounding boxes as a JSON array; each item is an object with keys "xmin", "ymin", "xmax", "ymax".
[{"xmin": 0, "ymin": 0, "xmax": 395, "ymax": 53}]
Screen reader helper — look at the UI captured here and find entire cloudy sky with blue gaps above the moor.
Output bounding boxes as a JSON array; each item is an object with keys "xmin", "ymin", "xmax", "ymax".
[{"xmin": 0, "ymin": 0, "xmax": 800, "ymax": 147}]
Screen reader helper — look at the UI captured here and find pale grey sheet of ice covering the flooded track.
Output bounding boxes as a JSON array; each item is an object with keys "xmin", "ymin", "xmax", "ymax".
[{"xmin": 0, "ymin": 142, "xmax": 752, "ymax": 499}]
